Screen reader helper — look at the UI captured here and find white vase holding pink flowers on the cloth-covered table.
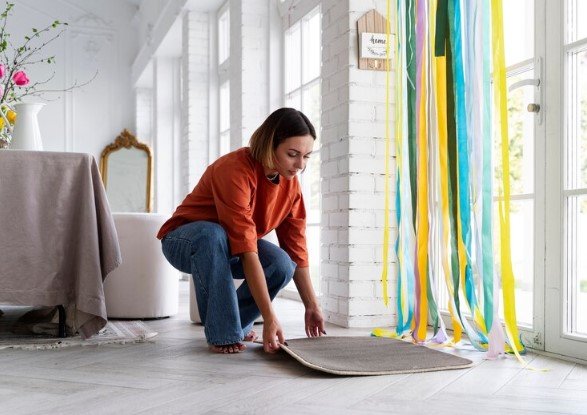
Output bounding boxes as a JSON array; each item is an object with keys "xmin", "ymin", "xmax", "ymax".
[{"xmin": 10, "ymin": 102, "xmax": 45, "ymax": 151}]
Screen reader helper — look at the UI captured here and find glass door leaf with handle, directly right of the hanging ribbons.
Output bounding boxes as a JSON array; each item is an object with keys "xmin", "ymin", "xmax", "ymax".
[{"xmin": 494, "ymin": 0, "xmax": 544, "ymax": 350}]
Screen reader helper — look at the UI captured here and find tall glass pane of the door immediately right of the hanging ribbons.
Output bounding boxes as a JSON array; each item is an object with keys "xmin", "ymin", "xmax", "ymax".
[{"xmin": 493, "ymin": 0, "xmax": 539, "ymax": 328}]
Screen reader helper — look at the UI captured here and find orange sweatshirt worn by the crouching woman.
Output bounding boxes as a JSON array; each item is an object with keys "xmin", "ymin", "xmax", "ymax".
[{"xmin": 157, "ymin": 147, "xmax": 309, "ymax": 267}]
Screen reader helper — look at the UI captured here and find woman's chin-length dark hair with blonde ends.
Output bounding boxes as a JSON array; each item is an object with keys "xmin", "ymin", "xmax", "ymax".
[{"xmin": 249, "ymin": 108, "xmax": 316, "ymax": 169}]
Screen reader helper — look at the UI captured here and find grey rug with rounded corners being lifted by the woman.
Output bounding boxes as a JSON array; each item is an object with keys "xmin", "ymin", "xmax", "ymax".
[{"xmin": 281, "ymin": 336, "xmax": 473, "ymax": 376}]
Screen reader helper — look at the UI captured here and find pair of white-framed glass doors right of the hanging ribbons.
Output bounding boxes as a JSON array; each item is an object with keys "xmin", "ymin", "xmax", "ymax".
[{"xmin": 422, "ymin": 0, "xmax": 587, "ymax": 360}]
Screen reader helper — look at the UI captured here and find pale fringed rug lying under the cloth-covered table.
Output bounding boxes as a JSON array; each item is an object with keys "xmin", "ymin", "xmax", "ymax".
[{"xmin": 0, "ymin": 306, "xmax": 157, "ymax": 350}]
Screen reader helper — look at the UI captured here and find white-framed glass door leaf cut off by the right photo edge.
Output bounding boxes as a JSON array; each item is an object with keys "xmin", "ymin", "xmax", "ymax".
[{"xmin": 545, "ymin": 0, "xmax": 587, "ymax": 360}]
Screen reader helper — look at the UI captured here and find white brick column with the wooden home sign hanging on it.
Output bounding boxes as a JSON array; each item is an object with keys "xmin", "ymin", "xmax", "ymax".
[{"xmin": 320, "ymin": 0, "xmax": 397, "ymax": 327}]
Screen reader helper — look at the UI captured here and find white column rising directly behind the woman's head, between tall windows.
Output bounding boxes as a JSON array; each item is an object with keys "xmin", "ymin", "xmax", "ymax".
[{"xmin": 229, "ymin": 0, "xmax": 270, "ymax": 150}]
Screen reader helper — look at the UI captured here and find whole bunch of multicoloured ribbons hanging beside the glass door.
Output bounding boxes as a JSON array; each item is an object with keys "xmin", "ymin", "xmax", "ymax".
[{"xmin": 373, "ymin": 0, "xmax": 525, "ymax": 357}]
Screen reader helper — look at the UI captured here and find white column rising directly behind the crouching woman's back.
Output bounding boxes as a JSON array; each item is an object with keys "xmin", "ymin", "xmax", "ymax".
[{"xmin": 180, "ymin": 11, "xmax": 211, "ymax": 190}]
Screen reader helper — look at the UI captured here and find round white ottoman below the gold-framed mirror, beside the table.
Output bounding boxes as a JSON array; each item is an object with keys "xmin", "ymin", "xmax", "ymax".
[{"xmin": 104, "ymin": 213, "xmax": 179, "ymax": 318}]
